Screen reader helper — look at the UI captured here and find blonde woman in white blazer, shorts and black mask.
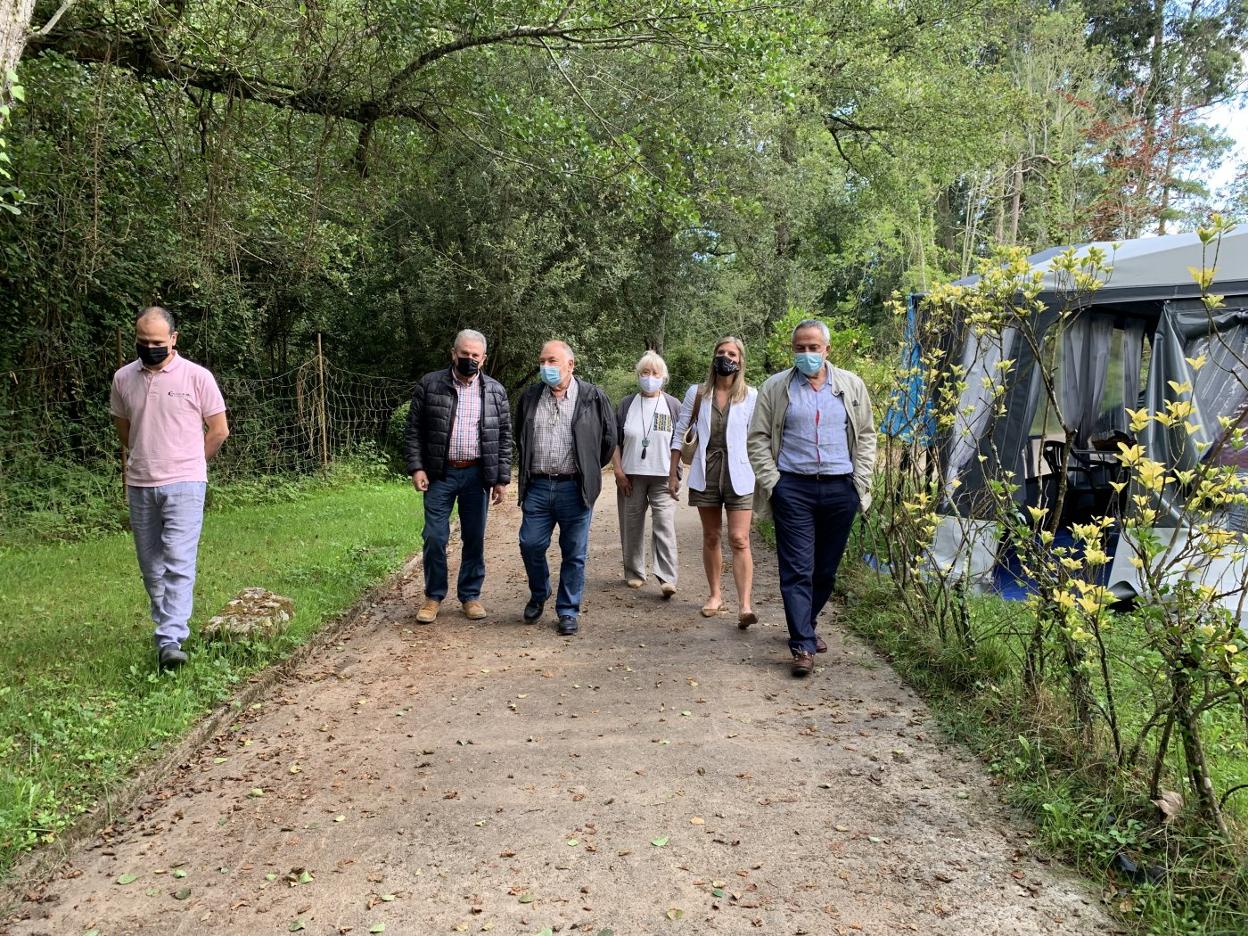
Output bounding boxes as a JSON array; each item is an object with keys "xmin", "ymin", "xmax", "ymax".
[{"xmin": 668, "ymin": 337, "xmax": 758, "ymax": 630}]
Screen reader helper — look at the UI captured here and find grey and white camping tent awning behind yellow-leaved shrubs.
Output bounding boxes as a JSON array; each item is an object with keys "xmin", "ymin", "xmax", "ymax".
[{"xmin": 912, "ymin": 227, "xmax": 1248, "ymax": 624}]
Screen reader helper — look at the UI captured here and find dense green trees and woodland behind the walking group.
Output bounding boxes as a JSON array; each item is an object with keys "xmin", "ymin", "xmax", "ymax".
[{"xmin": 0, "ymin": 0, "xmax": 1248, "ymax": 531}]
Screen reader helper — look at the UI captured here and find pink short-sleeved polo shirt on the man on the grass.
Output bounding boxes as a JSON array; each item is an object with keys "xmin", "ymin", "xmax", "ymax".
[{"xmin": 109, "ymin": 354, "xmax": 226, "ymax": 488}]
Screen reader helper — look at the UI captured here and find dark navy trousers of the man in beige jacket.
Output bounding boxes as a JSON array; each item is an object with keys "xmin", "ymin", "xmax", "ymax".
[{"xmin": 771, "ymin": 472, "xmax": 860, "ymax": 653}]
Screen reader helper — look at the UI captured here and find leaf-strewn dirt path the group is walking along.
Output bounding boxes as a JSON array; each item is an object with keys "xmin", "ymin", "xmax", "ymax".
[{"xmin": 2, "ymin": 487, "xmax": 1114, "ymax": 936}]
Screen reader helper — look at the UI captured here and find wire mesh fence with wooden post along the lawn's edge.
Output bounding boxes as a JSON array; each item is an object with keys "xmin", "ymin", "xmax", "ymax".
[{"xmin": 0, "ymin": 347, "xmax": 412, "ymax": 534}]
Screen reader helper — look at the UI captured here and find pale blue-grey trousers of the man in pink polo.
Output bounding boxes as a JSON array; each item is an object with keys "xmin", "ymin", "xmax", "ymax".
[{"xmin": 126, "ymin": 480, "xmax": 208, "ymax": 648}]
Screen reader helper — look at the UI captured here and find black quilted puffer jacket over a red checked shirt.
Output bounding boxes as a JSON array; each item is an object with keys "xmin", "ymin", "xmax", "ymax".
[{"xmin": 406, "ymin": 367, "xmax": 512, "ymax": 488}]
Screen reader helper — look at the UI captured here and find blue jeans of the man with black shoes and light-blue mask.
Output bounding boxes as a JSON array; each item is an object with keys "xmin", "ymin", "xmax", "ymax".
[{"xmin": 520, "ymin": 478, "xmax": 594, "ymax": 618}]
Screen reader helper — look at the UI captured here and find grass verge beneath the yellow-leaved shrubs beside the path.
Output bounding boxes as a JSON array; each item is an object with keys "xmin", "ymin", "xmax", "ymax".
[{"xmin": 840, "ymin": 562, "xmax": 1248, "ymax": 936}]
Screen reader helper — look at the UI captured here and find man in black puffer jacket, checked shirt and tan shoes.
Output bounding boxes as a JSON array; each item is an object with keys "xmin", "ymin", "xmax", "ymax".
[{"xmin": 406, "ymin": 329, "xmax": 512, "ymax": 624}]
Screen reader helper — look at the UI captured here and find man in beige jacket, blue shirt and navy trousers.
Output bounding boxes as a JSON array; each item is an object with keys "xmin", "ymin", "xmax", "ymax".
[{"xmin": 746, "ymin": 319, "xmax": 875, "ymax": 676}]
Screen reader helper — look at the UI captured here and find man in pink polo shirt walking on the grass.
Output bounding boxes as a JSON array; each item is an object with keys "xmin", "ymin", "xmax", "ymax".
[{"xmin": 109, "ymin": 312, "xmax": 230, "ymax": 669}]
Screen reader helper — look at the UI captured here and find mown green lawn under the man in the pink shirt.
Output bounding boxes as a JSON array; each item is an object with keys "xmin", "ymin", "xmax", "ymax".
[{"xmin": 0, "ymin": 479, "xmax": 421, "ymax": 875}]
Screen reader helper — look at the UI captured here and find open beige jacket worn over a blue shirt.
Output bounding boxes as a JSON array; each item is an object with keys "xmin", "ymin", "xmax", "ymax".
[{"xmin": 745, "ymin": 364, "xmax": 875, "ymax": 519}]
